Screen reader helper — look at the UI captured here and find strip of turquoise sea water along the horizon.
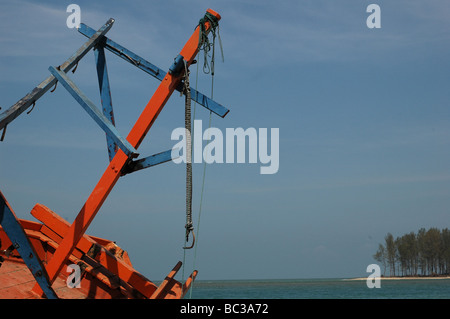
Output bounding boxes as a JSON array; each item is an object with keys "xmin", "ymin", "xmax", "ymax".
[{"xmin": 185, "ymin": 279, "xmax": 450, "ymax": 299}]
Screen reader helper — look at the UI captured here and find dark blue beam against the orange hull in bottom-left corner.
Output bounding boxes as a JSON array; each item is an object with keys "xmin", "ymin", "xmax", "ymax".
[{"xmin": 0, "ymin": 192, "xmax": 58, "ymax": 299}]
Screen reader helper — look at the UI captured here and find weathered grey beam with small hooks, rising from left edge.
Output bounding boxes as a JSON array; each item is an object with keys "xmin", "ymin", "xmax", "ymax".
[{"xmin": 0, "ymin": 19, "xmax": 114, "ymax": 130}]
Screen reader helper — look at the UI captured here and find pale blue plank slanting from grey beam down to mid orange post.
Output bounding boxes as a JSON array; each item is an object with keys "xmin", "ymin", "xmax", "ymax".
[{"xmin": 49, "ymin": 66, "xmax": 139, "ymax": 157}]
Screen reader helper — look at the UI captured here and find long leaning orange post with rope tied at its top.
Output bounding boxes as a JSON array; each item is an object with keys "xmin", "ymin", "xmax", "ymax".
[{"xmin": 33, "ymin": 9, "xmax": 220, "ymax": 294}]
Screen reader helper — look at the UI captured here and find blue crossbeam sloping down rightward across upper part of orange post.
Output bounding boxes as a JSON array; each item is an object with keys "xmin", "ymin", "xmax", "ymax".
[{"xmin": 78, "ymin": 23, "xmax": 230, "ymax": 117}]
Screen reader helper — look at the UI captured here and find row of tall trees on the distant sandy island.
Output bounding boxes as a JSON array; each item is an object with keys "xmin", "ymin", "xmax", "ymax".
[{"xmin": 373, "ymin": 228, "xmax": 450, "ymax": 276}]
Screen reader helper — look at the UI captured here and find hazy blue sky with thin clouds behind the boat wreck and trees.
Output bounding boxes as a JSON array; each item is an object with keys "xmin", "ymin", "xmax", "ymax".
[{"xmin": 0, "ymin": 0, "xmax": 450, "ymax": 281}]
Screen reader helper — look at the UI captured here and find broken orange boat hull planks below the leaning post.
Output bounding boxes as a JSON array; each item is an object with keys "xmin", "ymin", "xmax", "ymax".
[{"xmin": 0, "ymin": 215, "xmax": 190, "ymax": 299}]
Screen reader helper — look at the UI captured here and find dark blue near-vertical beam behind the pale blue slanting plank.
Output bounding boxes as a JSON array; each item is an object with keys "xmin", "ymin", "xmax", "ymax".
[{"xmin": 94, "ymin": 42, "xmax": 117, "ymax": 161}]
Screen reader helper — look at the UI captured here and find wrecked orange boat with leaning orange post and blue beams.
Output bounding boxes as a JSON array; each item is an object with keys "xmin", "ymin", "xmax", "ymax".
[{"xmin": 0, "ymin": 9, "xmax": 228, "ymax": 299}]
